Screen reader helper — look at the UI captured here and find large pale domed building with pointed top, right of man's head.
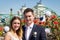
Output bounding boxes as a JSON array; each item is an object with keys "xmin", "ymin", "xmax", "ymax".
[{"xmin": 33, "ymin": 0, "xmax": 56, "ymax": 18}]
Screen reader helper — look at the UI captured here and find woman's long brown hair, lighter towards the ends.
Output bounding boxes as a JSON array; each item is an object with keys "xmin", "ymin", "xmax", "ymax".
[{"xmin": 10, "ymin": 16, "xmax": 23, "ymax": 37}]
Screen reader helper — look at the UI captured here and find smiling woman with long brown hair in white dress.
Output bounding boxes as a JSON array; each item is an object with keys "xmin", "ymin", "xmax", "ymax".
[{"xmin": 4, "ymin": 16, "xmax": 23, "ymax": 40}]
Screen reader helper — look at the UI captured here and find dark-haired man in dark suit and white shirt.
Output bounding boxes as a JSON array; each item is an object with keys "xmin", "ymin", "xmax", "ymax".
[{"xmin": 23, "ymin": 8, "xmax": 46, "ymax": 40}]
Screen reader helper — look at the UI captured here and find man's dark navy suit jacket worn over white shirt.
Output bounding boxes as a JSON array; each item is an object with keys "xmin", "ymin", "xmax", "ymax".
[{"xmin": 22, "ymin": 24, "xmax": 47, "ymax": 40}]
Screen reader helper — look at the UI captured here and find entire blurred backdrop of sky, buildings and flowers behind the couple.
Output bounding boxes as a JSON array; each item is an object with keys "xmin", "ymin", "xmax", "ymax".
[{"xmin": 0, "ymin": 0, "xmax": 60, "ymax": 40}]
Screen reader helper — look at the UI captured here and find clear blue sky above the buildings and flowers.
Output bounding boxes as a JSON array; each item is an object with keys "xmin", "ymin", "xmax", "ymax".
[{"xmin": 0, "ymin": 0, "xmax": 60, "ymax": 15}]
